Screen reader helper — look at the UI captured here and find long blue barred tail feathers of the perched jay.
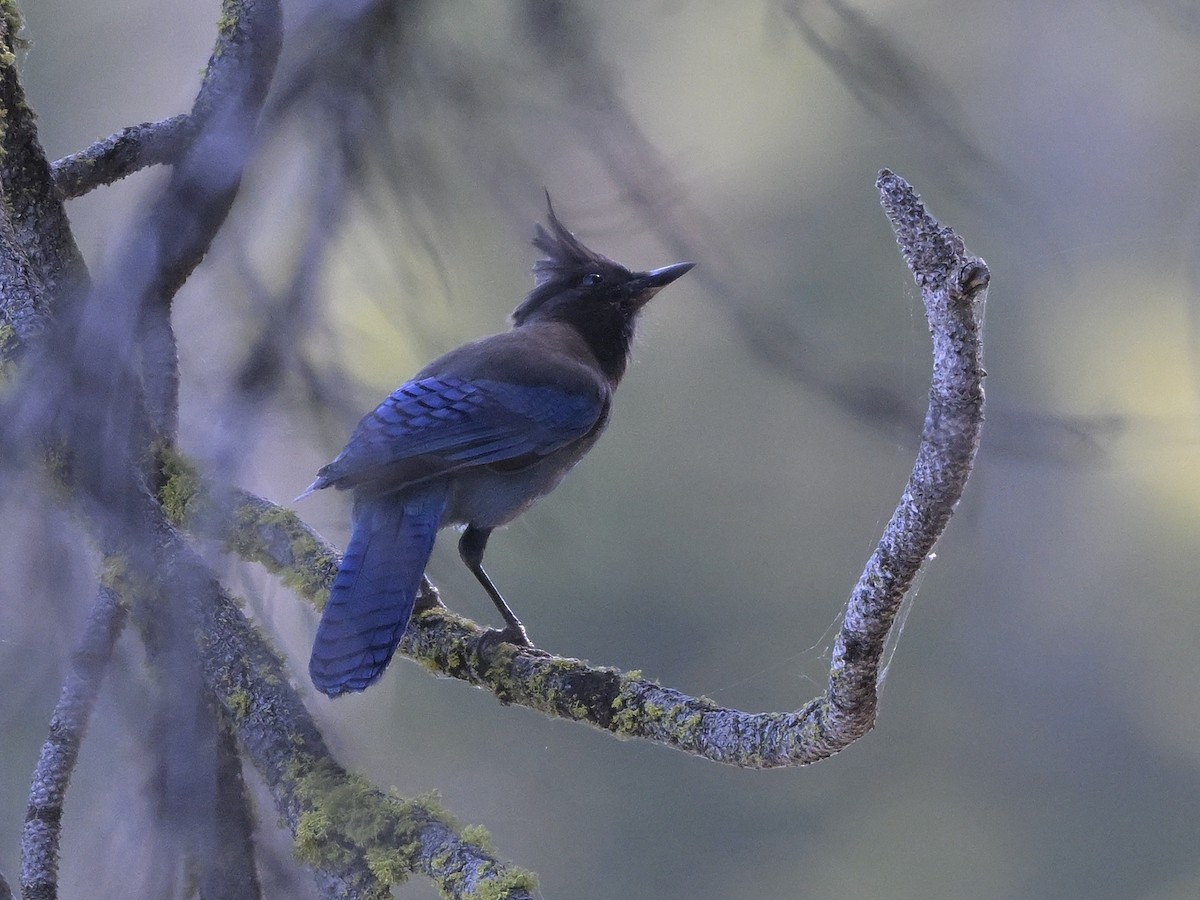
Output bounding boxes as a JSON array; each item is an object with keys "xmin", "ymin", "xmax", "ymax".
[{"xmin": 308, "ymin": 484, "xmax": 446, "ymax": 697}]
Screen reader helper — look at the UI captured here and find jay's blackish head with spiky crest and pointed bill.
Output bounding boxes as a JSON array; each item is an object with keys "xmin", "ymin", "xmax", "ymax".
[{"xmin": 511, "ymin": 193, "xmax": 695, "ymax": 380}]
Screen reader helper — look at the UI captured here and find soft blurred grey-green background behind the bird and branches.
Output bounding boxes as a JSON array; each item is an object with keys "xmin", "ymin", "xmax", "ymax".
[{"xmin": 0, "ymin": 0, "xmax": 1200, "ymax": 900}]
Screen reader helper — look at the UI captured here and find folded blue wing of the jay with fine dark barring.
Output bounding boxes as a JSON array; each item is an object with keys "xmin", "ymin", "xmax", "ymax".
[{"xmin": 310, "ymin": 377, "xmax": 605, "ymax": 491}]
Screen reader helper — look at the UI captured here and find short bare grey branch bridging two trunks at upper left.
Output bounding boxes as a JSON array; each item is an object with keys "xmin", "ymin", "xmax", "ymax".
[{"xmin": 50, "ymin": 115, "xmax": 196, "ymax": 199}]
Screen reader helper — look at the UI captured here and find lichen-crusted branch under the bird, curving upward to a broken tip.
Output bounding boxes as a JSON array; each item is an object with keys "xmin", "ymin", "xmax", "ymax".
[{"xmin": 193, "ymin": 170, "xmax": 990, "ymax": 768}]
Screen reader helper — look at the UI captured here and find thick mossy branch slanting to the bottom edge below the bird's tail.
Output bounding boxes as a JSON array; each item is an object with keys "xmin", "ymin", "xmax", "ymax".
[{"xmin": 156, "ymin": 511, "xmax": 534, "ymax": 900}]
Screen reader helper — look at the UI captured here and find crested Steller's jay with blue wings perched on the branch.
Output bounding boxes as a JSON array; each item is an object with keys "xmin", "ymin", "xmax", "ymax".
[{"xmin": 296, "ymin": 194, "xmax": 694, "ymax": 697}]
